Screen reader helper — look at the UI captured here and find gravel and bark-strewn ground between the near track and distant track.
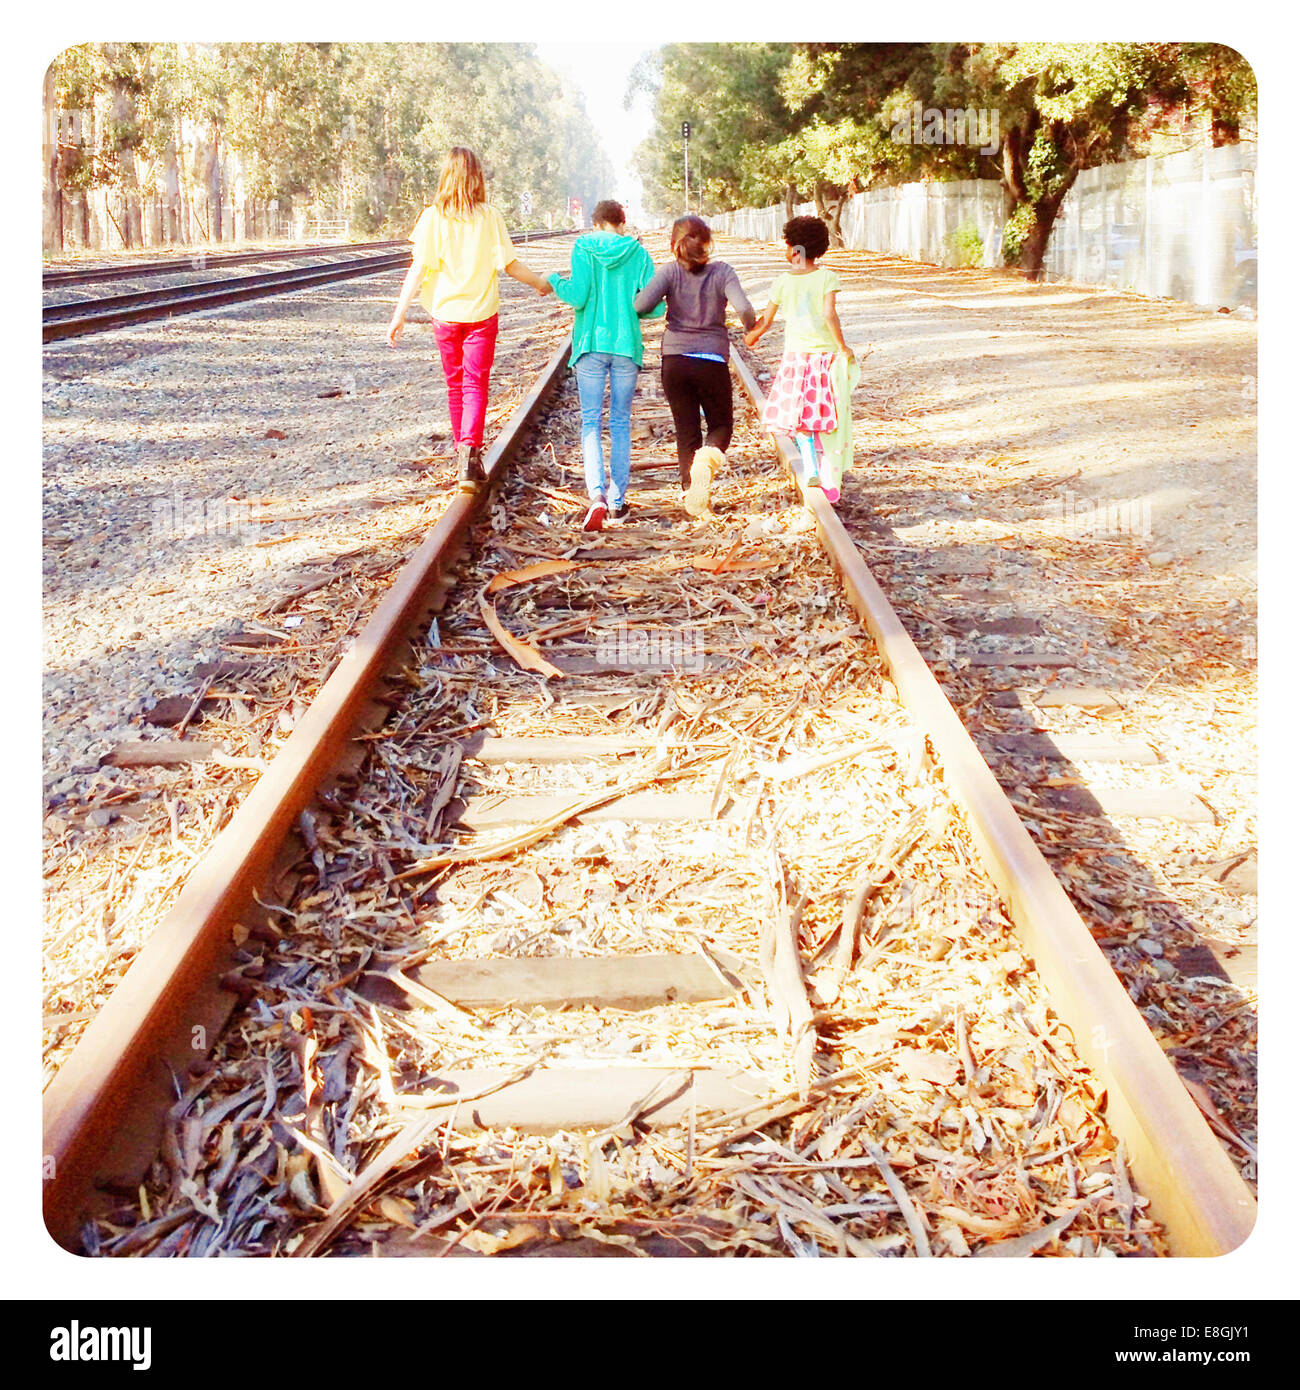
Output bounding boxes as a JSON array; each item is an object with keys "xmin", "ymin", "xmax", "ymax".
[{"xmin": 43, "ymin": 242, "xmax": 569, "ymax": 1076}]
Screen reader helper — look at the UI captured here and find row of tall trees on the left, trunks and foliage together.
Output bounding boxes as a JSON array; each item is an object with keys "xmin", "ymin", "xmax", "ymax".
[{"xmin": 44, "ymin": 43, "xmax": 613, "ymax": 252}]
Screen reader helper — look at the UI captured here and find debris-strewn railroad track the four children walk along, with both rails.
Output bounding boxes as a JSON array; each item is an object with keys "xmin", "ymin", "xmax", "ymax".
[{"xmin": 44, "ymin": 319, "xmax": 1254, "ymax": 1257}]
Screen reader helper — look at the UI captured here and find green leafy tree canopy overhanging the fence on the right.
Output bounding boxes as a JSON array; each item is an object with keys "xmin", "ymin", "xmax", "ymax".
[{"xmin": 634, "ymin": 43, "xmax": 1257, "ymax": 274}]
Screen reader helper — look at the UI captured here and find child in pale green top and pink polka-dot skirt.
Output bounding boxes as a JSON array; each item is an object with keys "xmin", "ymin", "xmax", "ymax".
[{"xmin": 745, "ymin": 217, "xmax": 854, "ymax": 502}]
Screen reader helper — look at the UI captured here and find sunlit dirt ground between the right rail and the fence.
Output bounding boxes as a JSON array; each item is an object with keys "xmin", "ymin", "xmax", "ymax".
[{"xmin": 723, "ymin": 242, "xmax": 1258, "ymax": 1183}]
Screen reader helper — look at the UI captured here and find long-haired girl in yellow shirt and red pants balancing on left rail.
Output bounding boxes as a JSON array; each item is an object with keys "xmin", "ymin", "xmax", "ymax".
[{"xmin": 388, "ymin": 146, "xmax": 552, "ymax": 492}]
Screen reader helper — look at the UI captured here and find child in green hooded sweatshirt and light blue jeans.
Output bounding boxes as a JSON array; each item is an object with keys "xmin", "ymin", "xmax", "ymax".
[{"xmin": 546, "ymin": 200, "xmax": 665, "ymax": 531}]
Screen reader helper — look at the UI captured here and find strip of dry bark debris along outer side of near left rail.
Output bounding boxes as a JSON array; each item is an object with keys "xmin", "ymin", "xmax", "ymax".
[{"xmin": 42, "ymin": 344, "xmax": 570, "ymax": 1081}]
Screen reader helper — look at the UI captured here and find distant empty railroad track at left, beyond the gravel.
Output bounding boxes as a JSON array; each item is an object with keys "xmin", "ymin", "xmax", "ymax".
[{"xmin": 42, "ymin": 232, "xmax": 571, "ymax": 342}]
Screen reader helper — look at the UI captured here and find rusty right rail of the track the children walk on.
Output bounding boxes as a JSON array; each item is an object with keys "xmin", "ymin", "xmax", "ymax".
[{"xmin": 731, "ymin": 354, "xmax": 1256, "ymax": 1255}]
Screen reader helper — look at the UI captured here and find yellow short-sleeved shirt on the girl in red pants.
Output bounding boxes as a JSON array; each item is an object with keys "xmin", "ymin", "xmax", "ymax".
[{"xmin": 410, "ymin": 203, "xmax": 514, "ymax": 324}]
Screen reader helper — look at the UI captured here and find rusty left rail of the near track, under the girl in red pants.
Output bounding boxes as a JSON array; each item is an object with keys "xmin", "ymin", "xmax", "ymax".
[{"xmin": 42, "ymin": 336, "xmax": 570, "ymax": 1252}]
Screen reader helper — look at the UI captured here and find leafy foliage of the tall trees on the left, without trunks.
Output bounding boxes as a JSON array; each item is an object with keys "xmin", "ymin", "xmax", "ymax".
[{"xmin": 40, "ymin": 43, "xmax": 613, "ymax": 243}]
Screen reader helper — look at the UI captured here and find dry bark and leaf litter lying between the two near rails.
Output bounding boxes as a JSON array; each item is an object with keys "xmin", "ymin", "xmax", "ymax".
[{"xmin": 89, "ymin": 319, "xmax": 1164, "ymax": 1257}]
